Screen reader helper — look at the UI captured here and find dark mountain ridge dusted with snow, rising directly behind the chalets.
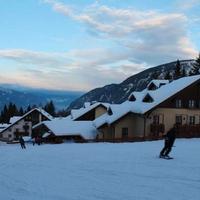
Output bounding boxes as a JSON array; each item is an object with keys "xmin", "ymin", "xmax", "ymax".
[{"xmin": 68, "ymin": 60, "xmax": 194, "ymax": 109}]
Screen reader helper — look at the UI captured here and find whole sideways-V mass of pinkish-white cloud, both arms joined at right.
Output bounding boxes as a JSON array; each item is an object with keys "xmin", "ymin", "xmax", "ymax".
[{"xmin": 0, "ymin": 0, "xmax": 197, "ymax": 90}]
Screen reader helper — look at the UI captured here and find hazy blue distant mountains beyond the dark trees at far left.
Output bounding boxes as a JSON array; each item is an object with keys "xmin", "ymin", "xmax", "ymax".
[{"xmin": 0, "ymin": 84, "xmax": 83, "ymax": 110}]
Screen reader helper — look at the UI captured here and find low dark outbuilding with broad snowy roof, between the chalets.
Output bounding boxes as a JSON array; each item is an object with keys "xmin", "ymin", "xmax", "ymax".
[{"xmin": 32, "ymin": 118, "xmax": 98, "ymax": 143}]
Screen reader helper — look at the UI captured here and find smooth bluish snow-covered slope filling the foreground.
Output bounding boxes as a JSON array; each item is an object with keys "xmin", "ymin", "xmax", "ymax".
[{"xmin": 0, "ymin": 139, "xmax": 200, "ymax": 200}]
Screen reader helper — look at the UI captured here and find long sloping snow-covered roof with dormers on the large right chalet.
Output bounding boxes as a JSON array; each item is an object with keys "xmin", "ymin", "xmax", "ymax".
[{"xmin": 94, "ymin": 75, "xmax": 200, "ymax": 128}]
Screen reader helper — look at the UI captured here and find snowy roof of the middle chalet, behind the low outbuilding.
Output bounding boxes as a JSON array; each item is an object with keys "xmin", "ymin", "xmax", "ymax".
[{"xmin": 71, "ymin": 102, "xmax": 110, "ymax": 120}]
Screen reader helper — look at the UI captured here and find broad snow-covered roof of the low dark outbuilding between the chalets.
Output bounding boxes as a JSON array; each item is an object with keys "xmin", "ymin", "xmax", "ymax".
[{"xmin": 33, "ymin": 118, "xmax": 98, "ymax": 140}]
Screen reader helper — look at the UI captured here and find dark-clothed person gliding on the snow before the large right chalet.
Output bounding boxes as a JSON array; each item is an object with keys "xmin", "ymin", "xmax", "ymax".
[{"xmin": 160, "ymin": 127, "xmax": 176, "ymax": 159}]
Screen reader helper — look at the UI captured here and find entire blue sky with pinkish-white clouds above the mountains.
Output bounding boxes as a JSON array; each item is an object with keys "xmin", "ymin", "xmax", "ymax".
[{"xmin": 0, "ymin": 0, "xmax": 200, "ymax": 91}]
